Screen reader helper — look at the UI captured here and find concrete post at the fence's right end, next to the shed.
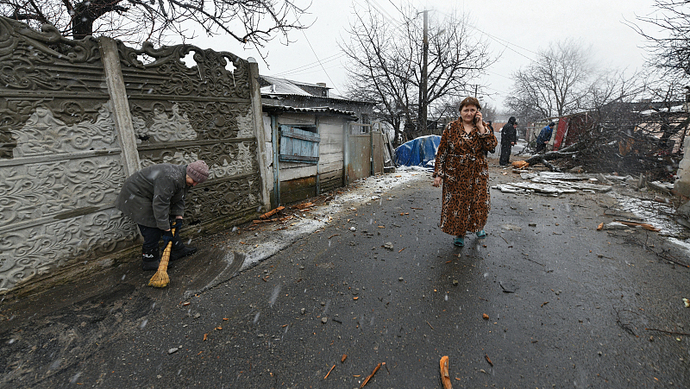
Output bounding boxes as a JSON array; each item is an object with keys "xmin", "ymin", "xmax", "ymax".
[{"xmin": 247, "ymin": 57, "xmax": 277, "ymax": 211}]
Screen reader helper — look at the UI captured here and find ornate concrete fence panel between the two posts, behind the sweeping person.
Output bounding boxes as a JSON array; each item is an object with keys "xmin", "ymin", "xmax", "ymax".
[{"xmin": 118, "ymin": 43, "xmax": 262, "ymax": 223}]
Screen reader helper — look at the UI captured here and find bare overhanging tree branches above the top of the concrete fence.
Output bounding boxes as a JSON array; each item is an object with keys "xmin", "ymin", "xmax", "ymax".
[{"xmin": 0, "ymin": 0, "xmax": 308, "ymax": 48}]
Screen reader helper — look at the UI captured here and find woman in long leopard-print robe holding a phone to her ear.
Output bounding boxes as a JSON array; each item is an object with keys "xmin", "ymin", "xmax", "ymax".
[{"xmin": 433, "ymin": 97, "xmax": 498, "ymax": 247}]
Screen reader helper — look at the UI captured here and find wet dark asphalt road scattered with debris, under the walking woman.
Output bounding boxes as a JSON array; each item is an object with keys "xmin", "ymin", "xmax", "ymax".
[{"xmin": 0, "ymin": 168, "xmax": 690, "ymax": 388}]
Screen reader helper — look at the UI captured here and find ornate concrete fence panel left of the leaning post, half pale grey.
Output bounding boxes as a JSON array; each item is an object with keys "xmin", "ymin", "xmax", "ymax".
[{"xmin": 0, "ymin": 18, "xmax": 138, "ymax": 290}]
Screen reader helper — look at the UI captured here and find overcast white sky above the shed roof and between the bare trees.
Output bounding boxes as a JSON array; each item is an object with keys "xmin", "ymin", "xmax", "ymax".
[{"xmin": 189, "ymin": 0, "xmax": 653, "ymax": 109}]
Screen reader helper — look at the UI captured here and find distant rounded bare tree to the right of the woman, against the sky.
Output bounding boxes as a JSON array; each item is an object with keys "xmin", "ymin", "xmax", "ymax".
[{"xmin": 506, "ymin": 40, "xmax": 594, "ymax": 121}]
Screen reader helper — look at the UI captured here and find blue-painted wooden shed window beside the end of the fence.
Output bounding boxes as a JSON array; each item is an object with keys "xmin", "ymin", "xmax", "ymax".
[{"xmin": 279, "ymin": 125, "xmax": 321, "ymax": 164}]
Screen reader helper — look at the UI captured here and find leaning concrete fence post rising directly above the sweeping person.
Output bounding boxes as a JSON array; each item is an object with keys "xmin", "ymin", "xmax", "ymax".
[{"xmin": 98, "ymin": 36, "xmax": 139, "ymax": 177}]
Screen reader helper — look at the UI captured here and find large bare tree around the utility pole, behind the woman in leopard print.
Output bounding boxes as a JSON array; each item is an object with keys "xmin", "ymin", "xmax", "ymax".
[{"xmin": 341, "ymin": 4, "xmax": 493, "ymax": 141}]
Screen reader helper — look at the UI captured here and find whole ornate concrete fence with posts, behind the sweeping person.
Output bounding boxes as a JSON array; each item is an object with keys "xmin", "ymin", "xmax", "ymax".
[{"xmin": 0, "ymin": 18, "xmax": 270, "ymax": 292}]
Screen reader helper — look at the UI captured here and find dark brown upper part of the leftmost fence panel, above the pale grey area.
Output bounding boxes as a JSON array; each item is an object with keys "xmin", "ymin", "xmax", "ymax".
[{"xmin": 0, "ymin": 18, "xmax": 108, "ymax": 160}]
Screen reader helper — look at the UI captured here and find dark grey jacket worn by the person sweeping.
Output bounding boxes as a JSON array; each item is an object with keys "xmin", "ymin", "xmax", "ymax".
[{"xmin": 115, "ymin": 163, "xmax": 188, "ymax": 230}]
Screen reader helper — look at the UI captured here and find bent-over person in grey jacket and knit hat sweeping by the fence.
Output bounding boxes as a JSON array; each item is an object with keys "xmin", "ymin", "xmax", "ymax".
[{"xmin": 115, "ymin": 160, "xmax": 208, "ymax": 270}]
